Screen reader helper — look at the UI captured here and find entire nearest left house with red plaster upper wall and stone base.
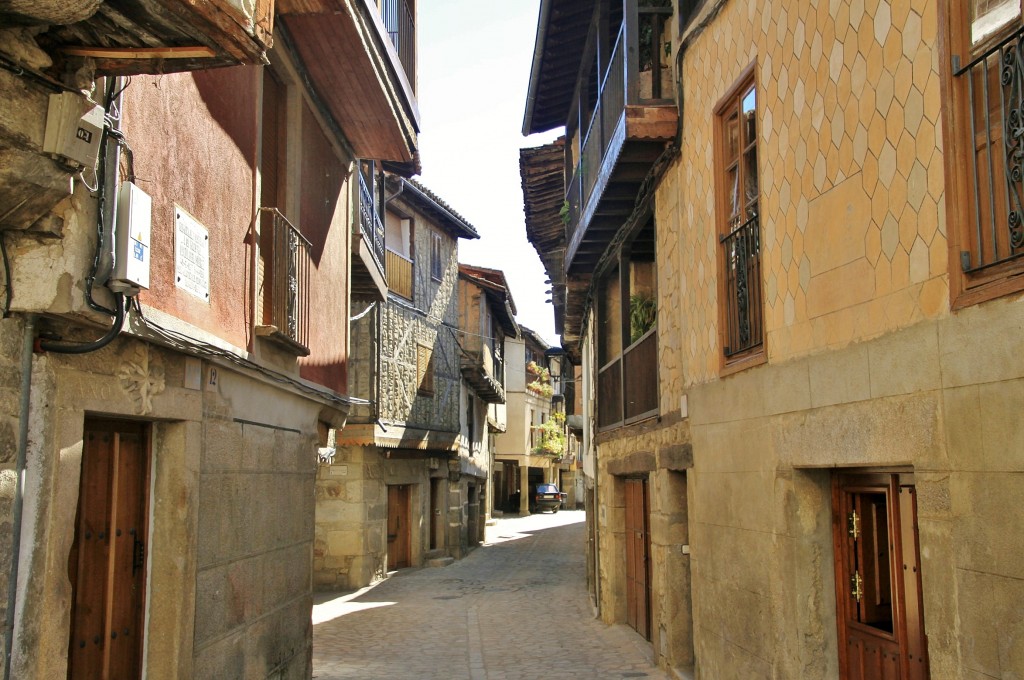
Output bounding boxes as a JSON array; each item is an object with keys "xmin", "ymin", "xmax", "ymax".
[{"xmin": 0, "ymin": 0, "xmax": 418, "ymax": 678}]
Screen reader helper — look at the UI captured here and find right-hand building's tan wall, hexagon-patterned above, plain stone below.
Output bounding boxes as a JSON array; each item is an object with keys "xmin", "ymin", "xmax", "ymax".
[{"xmin": 630, "ymin": 0, "xmax": 1024, "ymax": 678}]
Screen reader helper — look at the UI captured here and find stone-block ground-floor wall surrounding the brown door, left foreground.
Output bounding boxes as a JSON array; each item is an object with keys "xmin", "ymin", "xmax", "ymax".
[{"xmin": 0, "ymin": 321, "xmax": 323, "ymax": 678}]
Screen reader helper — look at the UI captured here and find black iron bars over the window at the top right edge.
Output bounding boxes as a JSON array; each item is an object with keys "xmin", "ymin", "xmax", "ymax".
[{"xmin": 953, "ymin": 23, "xmax": 1024, "ymax": 272}]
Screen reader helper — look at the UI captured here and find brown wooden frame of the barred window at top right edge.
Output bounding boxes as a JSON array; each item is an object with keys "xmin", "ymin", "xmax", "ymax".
[{"xmin": 939, "ymin": 0, "xmax": 1024, "ymax": 310}]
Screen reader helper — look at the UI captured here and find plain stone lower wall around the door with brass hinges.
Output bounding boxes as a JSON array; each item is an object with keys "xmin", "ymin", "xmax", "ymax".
[{"xmin": 690, "ymin": 300, "xmax": 1024, "ymax": 677}]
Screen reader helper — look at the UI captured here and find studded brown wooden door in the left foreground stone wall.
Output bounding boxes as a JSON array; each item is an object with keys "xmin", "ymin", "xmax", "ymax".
[{"xmin": 68, "ymin": 420, "xmax": 150, "ymax": 680}]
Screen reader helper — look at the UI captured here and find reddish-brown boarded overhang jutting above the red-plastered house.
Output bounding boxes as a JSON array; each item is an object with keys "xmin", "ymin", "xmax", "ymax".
[{"xmin": 278, "ymin": 0, "xmax": 420, "ymax": 175}]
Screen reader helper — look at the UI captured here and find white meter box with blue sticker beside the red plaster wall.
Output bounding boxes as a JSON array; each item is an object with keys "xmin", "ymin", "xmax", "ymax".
[{"xmin": 108, "ymin": 182, "xmax": 153, "ymax": 295}]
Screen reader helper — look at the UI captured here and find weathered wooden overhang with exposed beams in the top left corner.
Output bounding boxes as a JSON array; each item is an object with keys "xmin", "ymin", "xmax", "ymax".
[{"xmin": 14, "ymin": 0, "xmax": 274, "ymax": 76}]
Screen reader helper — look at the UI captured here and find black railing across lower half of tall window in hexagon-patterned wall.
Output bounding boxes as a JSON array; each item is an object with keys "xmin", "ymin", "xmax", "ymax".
[{"xmin": 720, "ymin": 215, "xmax": 764, "ymax": 357}]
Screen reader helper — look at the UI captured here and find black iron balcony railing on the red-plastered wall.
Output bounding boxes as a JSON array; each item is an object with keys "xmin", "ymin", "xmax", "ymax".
[{"xmin": 260, "ymin": 208, "xmax": 312, "ymax": 347}]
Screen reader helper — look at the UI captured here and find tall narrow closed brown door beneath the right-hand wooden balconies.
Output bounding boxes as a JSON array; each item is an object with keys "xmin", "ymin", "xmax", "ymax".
[{"xmin": 626, "ymin": 479, "xmax": 650, "ymax": 640}]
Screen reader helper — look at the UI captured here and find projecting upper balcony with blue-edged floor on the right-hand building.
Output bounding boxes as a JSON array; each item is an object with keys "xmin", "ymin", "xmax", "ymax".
[{"xmin": 565, "ymin": 0, "xmax": 679, "ymax": 274}]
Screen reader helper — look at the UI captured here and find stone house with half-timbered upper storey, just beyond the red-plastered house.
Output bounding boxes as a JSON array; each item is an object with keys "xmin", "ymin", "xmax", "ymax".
[{"xmin": 313, "ymin": 176, "xmax": 488, "ymax": 590}]
